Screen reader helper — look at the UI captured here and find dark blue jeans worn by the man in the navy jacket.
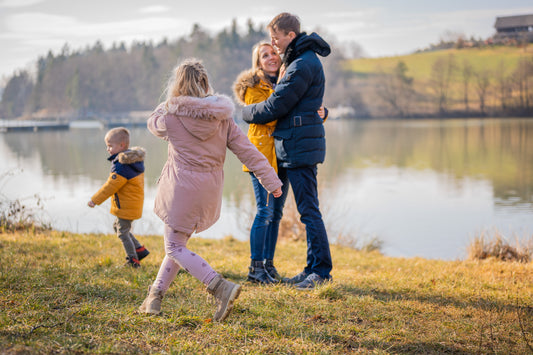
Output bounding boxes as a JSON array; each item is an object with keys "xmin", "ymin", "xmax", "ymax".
[{"xmin": 278, "ymin": 165, "xmax": 332, "ymax": 278}]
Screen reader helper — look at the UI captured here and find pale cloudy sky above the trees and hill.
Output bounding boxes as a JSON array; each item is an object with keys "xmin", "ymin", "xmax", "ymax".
[{"xmin": 0, "ymin": 0, "xmax": 533, "ymax": 84}]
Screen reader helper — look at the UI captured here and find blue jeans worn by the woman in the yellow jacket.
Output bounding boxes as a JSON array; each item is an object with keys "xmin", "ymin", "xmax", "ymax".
[{"xmin": 250, "ymin": 172, "xmax": 289, "ymax": 261}]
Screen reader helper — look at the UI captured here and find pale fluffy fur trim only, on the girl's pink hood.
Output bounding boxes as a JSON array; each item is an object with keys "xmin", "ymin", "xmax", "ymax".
[{"xmin": 166, "ymin": 94, "xmax": 235, "ymax": 121}]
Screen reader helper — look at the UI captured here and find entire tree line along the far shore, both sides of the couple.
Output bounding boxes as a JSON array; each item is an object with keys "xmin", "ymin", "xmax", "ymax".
[{"xmin": 0, "ymin": 20, "xmax": 533, "ymax": 119}]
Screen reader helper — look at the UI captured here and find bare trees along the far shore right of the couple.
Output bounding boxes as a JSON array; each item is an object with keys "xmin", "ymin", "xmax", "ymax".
[{"xmin": 368, "ymin": 54, "xmax": 533, "ymax": 117}]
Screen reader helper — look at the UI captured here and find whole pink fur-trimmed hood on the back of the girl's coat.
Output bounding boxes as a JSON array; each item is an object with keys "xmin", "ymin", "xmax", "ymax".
[{"xmin": 166, "ymin": 94, "xmax": 235, "ymax": 141}]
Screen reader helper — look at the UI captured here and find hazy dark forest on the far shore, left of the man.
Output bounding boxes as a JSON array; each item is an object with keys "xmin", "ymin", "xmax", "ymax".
[{"xmin": 0, "ymin": 20, "xmax": 350, "ymax": 119}]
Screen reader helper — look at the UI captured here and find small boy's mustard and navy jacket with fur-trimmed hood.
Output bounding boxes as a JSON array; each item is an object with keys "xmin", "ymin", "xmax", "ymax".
[{"xmin": 91, "ymin": 147, "xmax": 146, "ymax": 220}]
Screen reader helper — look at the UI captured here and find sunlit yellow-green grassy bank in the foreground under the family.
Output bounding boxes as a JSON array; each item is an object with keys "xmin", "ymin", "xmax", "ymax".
[{"xmin": 0, "ymin": 232, "xmax": 533, "ymax": 354}]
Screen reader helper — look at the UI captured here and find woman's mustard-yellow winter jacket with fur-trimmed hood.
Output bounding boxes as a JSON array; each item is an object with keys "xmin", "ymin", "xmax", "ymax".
[{"xmin": 233, "ymin": 69, "xmax": 278, "ymax": 173}]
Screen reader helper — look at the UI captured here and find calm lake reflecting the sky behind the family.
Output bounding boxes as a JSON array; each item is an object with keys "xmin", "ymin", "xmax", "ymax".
[{"xmin": 0, "ymin": 119, "xmax": 533, "ymax": 260}]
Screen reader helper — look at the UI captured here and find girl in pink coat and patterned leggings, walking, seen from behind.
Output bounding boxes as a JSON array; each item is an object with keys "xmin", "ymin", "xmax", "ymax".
[{"xmin": 139, "ymin": 59, "xmax": 282, "ymax": 321}]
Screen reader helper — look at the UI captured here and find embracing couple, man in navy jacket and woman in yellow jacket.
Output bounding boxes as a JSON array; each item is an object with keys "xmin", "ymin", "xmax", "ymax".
[{"xmin": 234, "ymin": 13, "xmax": 332, "ymax": 289}]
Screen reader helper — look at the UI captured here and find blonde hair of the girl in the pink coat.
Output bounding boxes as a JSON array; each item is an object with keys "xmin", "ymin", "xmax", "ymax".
[{"xmin": 166, "ymin": 58, "xmax": 213, "ymax": 102}]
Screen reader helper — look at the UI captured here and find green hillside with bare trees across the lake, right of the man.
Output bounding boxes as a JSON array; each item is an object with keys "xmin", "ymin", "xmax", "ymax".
[{"xmin": 345, "ymin": 46, "xmax": 533, "ymax": 117}]
